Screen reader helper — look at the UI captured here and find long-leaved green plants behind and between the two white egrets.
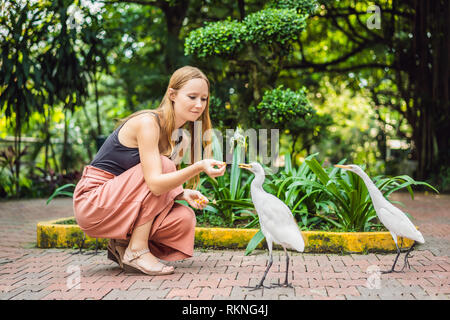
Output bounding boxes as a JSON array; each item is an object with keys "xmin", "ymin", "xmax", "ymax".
[{"xmin": 245, "ymin": 153, "xmax": 437, "ymax": 255}]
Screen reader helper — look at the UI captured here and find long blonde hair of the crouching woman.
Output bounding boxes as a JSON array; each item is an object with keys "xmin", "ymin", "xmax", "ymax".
[{"xmin": 116, "ymin": 66, "xmax": 212, "ymax": 189}]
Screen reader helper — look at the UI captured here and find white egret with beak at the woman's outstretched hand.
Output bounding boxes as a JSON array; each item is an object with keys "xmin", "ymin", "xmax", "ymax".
[{"xmin": 239, "ymin": 162, "xmax": 305, "ymax": 290}]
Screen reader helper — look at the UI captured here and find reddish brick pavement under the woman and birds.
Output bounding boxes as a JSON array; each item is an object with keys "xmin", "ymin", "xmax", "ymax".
[{"xmin": 0, "ymin": 193, "xmax": 450, "ymax": 300}]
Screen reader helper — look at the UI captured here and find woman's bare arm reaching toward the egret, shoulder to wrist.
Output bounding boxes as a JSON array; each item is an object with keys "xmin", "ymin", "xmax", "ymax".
[{"xmin": 136, "ymin": 115, "xmax": 205, "ymax": 195}]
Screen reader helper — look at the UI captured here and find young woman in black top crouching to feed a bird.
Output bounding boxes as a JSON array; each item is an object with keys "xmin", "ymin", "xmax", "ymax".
[{"xmin": 73, "ymin": 66, "xmax": 226, "ymax": 275}]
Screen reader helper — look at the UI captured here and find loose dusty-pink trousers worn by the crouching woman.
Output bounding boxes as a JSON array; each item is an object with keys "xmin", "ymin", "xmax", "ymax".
[{"xmin": 73, "ymin": 156, "xmax": 196, "ymax": 261}]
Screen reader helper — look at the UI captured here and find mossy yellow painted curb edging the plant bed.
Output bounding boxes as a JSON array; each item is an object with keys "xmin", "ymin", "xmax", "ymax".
[{"xmin": 37, "ymin": 217, "xmax": 414, "ymax": 253}]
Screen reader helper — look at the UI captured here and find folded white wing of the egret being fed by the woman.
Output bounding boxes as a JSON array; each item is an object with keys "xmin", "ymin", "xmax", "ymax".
[{"xmin": 254, "ymin": 194, "xmax": 305, "ymax": 252}]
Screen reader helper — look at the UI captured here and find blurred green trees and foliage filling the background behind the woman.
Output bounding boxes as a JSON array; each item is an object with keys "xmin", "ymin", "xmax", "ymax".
[{"xmin": 0, "ymin": 0, "xmax": 450, "ymax": 199}]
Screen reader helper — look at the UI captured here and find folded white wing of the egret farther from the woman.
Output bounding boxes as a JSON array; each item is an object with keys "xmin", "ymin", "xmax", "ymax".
[{"xmin": 379, "ymin": 204, "xmax": 425, "ymax": 243}]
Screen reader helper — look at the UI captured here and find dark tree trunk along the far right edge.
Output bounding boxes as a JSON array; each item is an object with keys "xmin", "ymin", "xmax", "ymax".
[{"xmin": 408, "ymin": 0, "xmax": 450, "ymax": 179}]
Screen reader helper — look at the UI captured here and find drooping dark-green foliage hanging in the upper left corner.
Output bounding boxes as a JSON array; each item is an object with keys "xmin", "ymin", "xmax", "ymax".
[{"xmin": 0, "ymin": 0, "xmax": 105, "ymax": 185}]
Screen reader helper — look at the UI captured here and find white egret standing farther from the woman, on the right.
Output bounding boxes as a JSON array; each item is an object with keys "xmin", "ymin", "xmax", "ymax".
[{"xmin": 334, "ymin": 164, "xmax": 425, "ymax": 273}]
